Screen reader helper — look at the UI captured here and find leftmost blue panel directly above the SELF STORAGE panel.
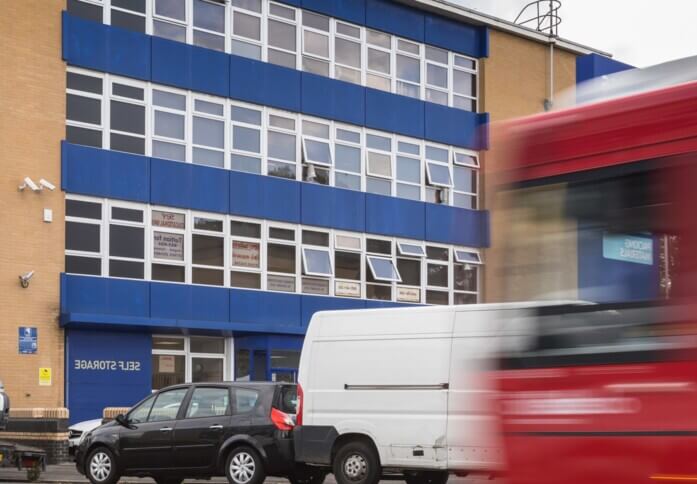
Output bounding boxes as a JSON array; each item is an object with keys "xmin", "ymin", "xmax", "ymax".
[{"xmin": 61, "ymin": 274, "xmax": 150, "ymax": 318}]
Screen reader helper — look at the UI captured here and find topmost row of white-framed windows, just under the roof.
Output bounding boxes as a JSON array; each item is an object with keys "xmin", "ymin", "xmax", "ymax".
[{"xmin": 68, "ymin": 0, "xmax": 477, "ymax": 111}]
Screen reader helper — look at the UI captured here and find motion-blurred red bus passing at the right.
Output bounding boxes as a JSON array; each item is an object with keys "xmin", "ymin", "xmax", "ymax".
[{"xmin": 489, "ymin": 65, "xmax": 697, "ymax": 484}]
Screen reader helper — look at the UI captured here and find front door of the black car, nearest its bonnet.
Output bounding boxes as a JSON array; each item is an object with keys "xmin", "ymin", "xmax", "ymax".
[{"xmin": 119, "ymin": 387, "xmax": 189, "ymax": 470}]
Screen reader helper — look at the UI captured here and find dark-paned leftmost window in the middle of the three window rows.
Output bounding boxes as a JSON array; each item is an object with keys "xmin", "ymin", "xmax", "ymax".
[{"xmin": 65, "ymin": 71, "xmax": 103, "ymax": 148}]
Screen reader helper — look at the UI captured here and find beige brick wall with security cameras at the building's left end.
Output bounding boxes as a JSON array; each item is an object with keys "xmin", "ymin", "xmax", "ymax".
[{"xmin": 0, "ymin": 0, "xmax": 65, "ymax": 407}]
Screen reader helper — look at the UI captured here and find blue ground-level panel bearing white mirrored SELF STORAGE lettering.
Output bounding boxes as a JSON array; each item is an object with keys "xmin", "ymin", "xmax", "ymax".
[{"xmin": 65, "ymin": 329, "xmax": 152, "ymax": 423}]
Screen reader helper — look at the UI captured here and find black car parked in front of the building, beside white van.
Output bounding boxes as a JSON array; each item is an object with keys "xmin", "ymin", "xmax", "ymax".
[{"xmin": 76, "ymin": 382, "xmax": 325, "ymax": 484}]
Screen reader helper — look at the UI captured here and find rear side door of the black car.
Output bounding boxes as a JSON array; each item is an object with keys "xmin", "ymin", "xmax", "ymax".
[{"xmin": 174, "ymin": 385, "xmax": 232, "ymax": 470}]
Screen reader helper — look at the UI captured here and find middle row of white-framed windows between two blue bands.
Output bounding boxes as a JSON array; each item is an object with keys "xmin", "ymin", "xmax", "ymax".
[{"xmin": 66, "ymin": 68, "xmax": 478, "ymax": 209}]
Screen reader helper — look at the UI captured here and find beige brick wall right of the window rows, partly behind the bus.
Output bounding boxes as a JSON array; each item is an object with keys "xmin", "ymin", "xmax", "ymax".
[{"xmin": 480, "ymin": 30, "xmax": 576, "ymax": 302}]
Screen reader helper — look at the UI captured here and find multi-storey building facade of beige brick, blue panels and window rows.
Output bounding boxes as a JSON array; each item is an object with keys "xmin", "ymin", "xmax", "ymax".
[{"xmin": 0, "ymin": 0, "xmax": 608, "ymax": 421}]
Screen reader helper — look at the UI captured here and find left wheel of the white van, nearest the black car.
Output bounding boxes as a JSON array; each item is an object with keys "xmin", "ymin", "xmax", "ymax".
[{"xmin": 333, "ymin": 441, "xmax": 381, "ymax": 484}]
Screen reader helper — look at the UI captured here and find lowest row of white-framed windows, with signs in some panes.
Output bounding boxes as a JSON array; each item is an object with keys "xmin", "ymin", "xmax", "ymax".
[{"xmin": 65, "ymin": 195, "xmax": 481, "ymax": 304}]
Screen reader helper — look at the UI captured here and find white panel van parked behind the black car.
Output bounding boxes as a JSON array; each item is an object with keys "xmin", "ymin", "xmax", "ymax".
[{"xmin": 295, "ymin": 304, "xmax": 528, "ymax": 484}]
